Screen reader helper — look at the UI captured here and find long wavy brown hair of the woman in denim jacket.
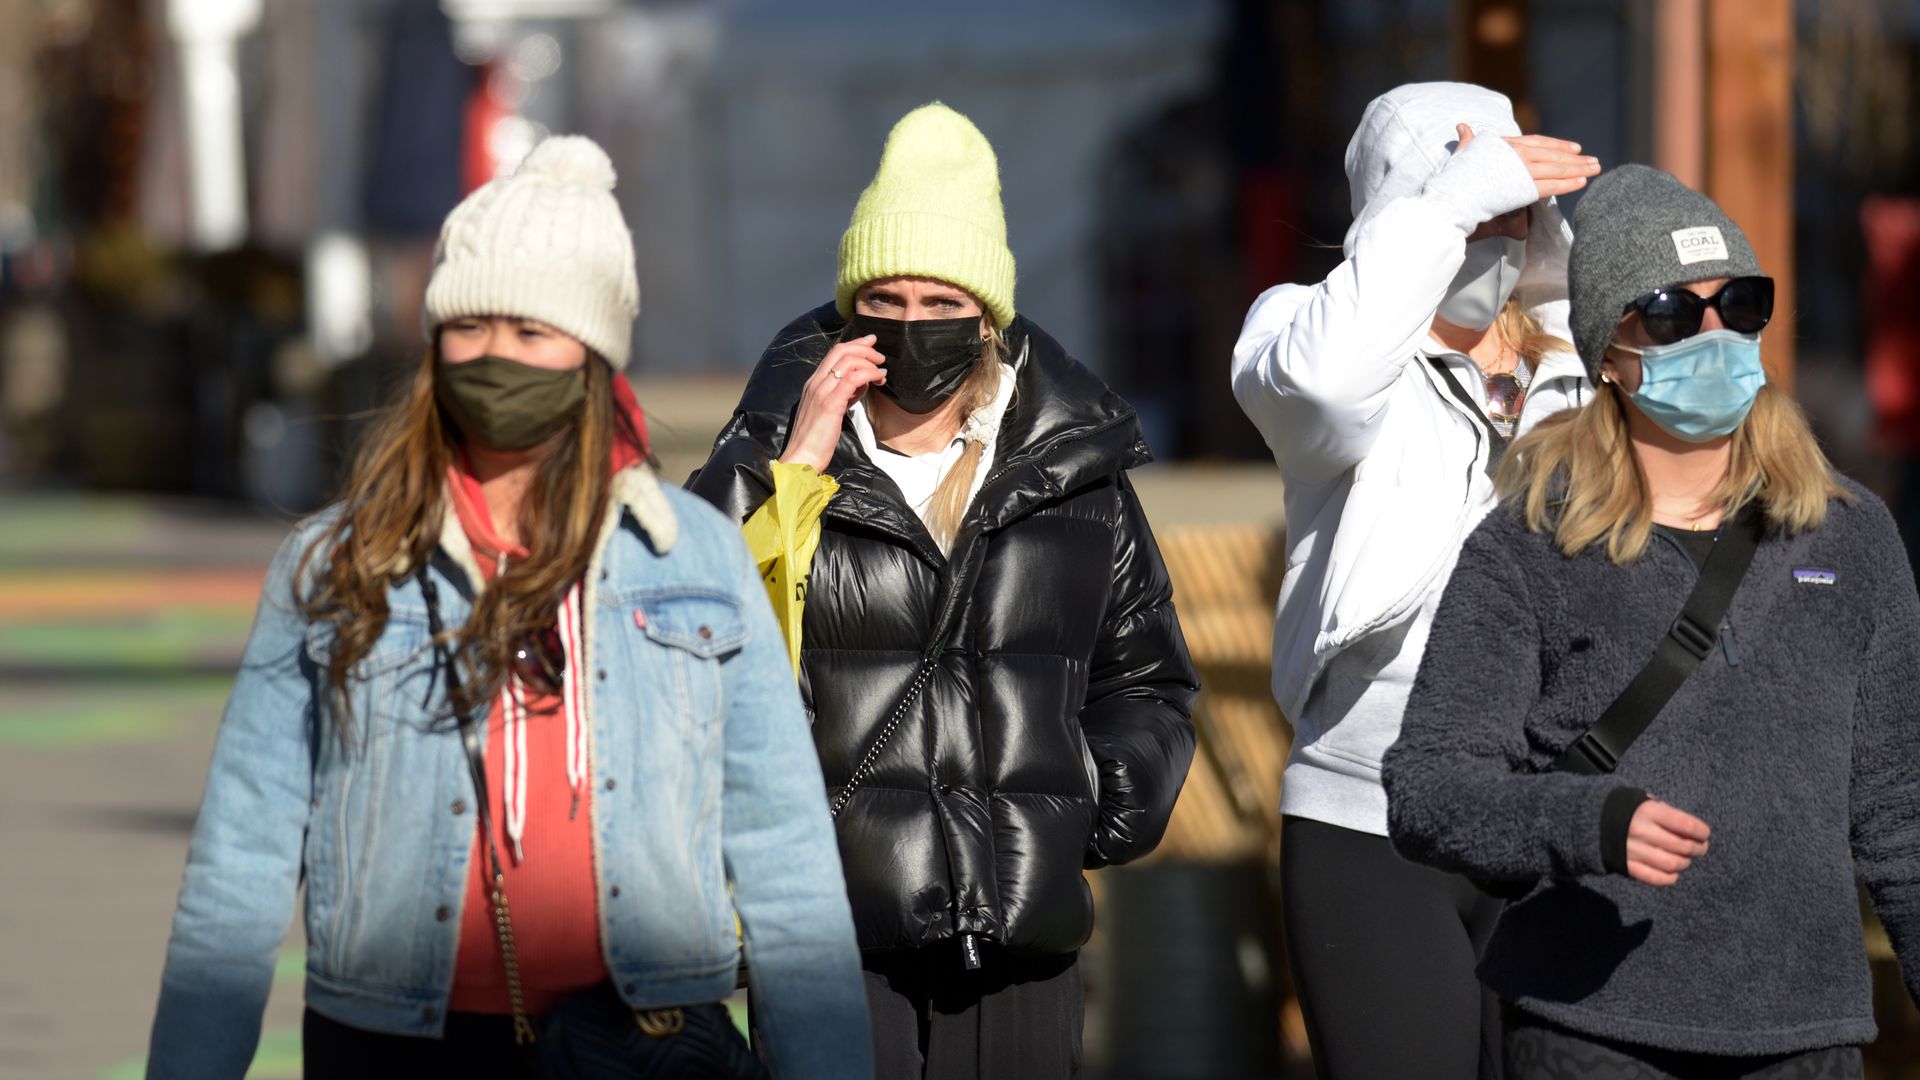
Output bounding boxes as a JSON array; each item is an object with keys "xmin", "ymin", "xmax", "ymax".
[{"xmin": 294, "ymin": 348, "xmax": 641, "ymax": 738}]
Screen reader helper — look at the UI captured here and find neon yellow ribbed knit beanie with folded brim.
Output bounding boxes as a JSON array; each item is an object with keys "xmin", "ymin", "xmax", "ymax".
[{"xmin": 833, "ymin": 102, "xmax": 1014, "ymax": 327}]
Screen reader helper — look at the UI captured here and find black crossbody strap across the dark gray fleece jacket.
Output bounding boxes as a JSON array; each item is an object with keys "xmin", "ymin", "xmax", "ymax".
[{"xmin": 1553, "ymin": 503, "xmax": 1766, "ymax": 776}]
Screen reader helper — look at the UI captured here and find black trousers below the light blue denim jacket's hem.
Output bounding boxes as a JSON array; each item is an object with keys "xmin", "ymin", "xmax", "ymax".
[{"xmin": 300, "ymin": 1009, "xmax": 540, "ymax": 1080}]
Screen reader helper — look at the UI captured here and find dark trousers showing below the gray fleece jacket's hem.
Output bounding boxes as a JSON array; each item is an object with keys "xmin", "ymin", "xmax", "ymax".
[{"xmin": 1505, "ymin": 1009, "xmax": 1862, "ymax": 1080}]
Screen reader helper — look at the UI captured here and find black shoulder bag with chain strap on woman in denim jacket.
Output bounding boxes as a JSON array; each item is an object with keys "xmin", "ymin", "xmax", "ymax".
[{"xmin": 417, "ymin": 565, "xmax": 768, "ymax": 1080}]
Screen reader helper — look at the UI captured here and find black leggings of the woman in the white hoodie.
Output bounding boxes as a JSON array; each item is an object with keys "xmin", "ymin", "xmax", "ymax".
[{"xmin": 1281, "ymin": 817, "xmax": 1501, "ymax": 1080}]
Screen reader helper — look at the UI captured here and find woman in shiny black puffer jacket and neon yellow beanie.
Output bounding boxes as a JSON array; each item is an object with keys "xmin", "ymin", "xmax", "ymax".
[{"xmin": 689, "ymin": 106, "xmax": 1196, "ymax": 1078}]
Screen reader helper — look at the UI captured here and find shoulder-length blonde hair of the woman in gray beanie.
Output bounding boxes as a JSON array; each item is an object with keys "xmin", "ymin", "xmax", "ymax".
[{"xmin": 1494, "ymin": 372, "xmax": 1851, "ymax": 563}]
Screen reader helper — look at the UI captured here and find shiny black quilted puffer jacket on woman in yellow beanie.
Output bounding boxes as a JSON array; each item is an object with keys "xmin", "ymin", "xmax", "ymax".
[{"xmin": 687, "ymin": 304, "xmax": 1198, "ymax": 953}]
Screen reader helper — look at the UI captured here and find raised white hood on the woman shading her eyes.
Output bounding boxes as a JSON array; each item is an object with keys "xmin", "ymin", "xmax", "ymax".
[{"xmin": 1344, "ymin": 83, "xmax": 1572, "ymax": 342}]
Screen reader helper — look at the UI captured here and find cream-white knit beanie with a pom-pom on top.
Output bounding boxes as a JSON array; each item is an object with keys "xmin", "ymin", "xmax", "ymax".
[{"xmin": 420, "ymin": 135, "xmax": 639, "ymax": 371}]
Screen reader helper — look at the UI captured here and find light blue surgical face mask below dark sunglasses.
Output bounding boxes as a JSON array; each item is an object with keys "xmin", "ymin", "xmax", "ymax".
[{"xmin": 1615, "ymin": 331, "xmax": 1766, "ymax": 442}]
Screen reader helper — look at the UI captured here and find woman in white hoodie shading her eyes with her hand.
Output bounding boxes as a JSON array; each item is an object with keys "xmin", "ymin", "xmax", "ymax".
[{"xmin": 1233, "ymin": 83, "xmax": 1599, "ymax": 1080}]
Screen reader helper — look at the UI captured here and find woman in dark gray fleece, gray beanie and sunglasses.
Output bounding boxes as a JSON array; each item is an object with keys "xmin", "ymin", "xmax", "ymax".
[{"xmin": 1384, "ymin": 165, "xmax": 1920, "ymax": 1080}]
